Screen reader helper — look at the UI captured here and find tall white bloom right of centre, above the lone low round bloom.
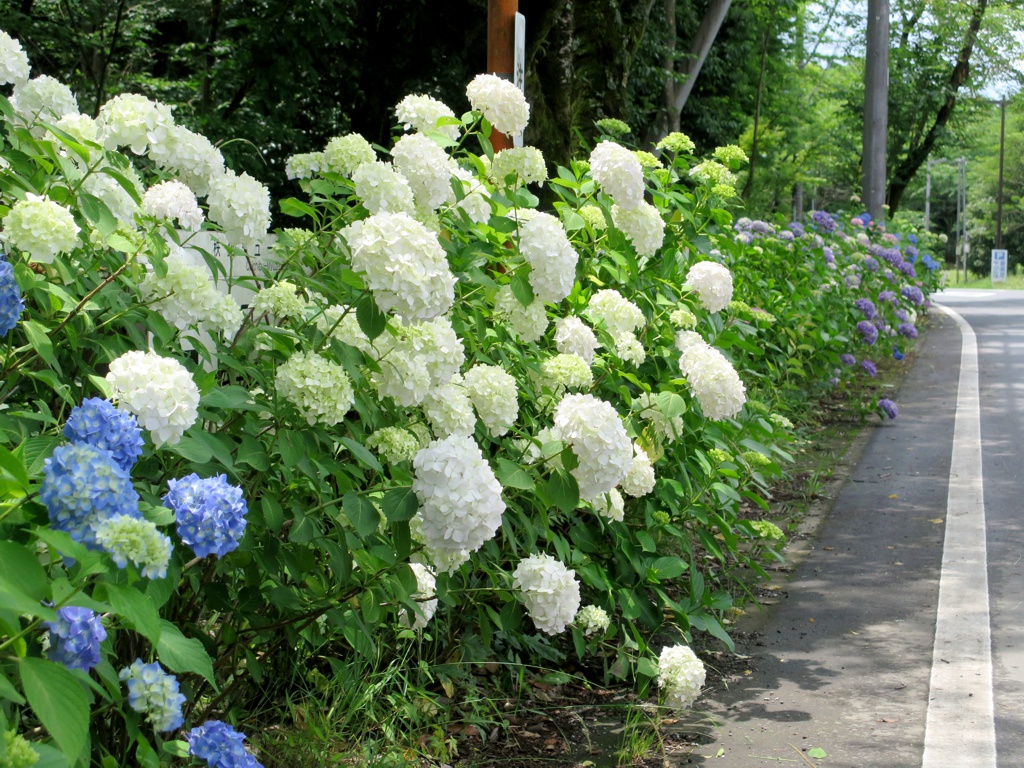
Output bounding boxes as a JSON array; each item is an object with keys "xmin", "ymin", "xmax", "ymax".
[{"xmin": 555, "ymin": 394, "xmax": 633, "ymax": 502}]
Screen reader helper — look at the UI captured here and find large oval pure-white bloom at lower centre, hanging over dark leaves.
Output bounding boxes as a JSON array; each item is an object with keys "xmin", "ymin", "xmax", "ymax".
[{"xmin": 413, "ymin": 435, "xmax": 505, "ymax": 566}]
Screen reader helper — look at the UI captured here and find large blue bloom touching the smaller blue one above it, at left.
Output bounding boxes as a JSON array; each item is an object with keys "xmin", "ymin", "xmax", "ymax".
[{"xmin": 39, "ymin": 443, "xmax": 140, "ymax": 548}]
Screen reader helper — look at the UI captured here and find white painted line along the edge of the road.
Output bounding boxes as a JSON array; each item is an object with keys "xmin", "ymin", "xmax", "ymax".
[{"xmin": 922, "ymin": 304, "xmax": 995, "ymax": 768}]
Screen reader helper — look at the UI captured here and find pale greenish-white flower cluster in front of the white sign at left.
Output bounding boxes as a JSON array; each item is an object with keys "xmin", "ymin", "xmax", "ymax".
[{"xmin": 139, "ymin": 252, "xmax": 244, "ymax": 338}]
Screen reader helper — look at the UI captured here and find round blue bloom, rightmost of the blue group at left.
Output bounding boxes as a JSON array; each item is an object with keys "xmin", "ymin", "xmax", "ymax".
[{"xmin": 164, "ymin": 473, "xmax": 248, "ymax": 557}]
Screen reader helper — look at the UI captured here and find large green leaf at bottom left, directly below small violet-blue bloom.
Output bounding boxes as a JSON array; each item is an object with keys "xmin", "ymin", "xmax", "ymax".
[{"xmin": 20, "ymin": 657, "xmax": 89, "ymax": 762}]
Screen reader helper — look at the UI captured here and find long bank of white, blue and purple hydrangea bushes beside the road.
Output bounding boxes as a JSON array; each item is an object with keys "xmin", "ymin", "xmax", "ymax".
[{"xmin": 0, "ymin": 34, "xmax": 935, "ymax": 766}]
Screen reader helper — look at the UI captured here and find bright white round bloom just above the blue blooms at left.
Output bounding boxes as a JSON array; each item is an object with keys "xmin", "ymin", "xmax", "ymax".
[{"xmin": 106, "ymin": 351, "xmax": 199, "ymax": 447}]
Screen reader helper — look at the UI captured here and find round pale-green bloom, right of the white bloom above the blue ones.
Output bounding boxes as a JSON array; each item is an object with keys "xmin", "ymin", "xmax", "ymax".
[{"xmin": 274, "ymin": 352, "xmax": 355, "ymax": 427}]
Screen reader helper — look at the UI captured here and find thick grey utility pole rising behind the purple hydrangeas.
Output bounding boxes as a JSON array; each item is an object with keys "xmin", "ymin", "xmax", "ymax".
[{"xmin": 861, "ymin": 0, "xmax": 889, "ymax": 222}]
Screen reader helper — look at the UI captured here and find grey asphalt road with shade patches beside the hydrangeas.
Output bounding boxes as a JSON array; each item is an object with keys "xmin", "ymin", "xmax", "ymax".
[{"xmin": 678, "ymin": 291, "xmax": 1024, "ymax": 768}]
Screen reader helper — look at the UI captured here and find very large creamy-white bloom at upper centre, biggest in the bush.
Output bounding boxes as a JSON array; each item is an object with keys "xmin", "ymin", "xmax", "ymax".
[{"xmin": 343, "ymin": 213, "xmax": 455, "ymax": 323}]
